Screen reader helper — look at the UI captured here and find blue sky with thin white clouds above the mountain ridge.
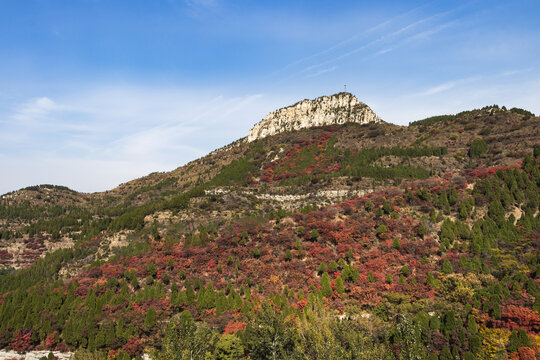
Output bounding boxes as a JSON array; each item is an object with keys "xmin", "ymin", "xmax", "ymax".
[{"xmin": 0, "ymin": 0, "xmax": 540, "ymax": 193}]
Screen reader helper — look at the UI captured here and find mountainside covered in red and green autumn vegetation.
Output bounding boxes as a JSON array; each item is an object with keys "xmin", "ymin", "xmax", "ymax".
[{"xmin": 0, "ymin": 94, "xmax": 540, "ymax": 359}]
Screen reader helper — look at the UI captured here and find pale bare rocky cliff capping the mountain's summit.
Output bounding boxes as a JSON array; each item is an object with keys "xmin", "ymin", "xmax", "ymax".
[{"xmin": 247, "ymin": 92, "xmax": 381, "ymax": 142}]
